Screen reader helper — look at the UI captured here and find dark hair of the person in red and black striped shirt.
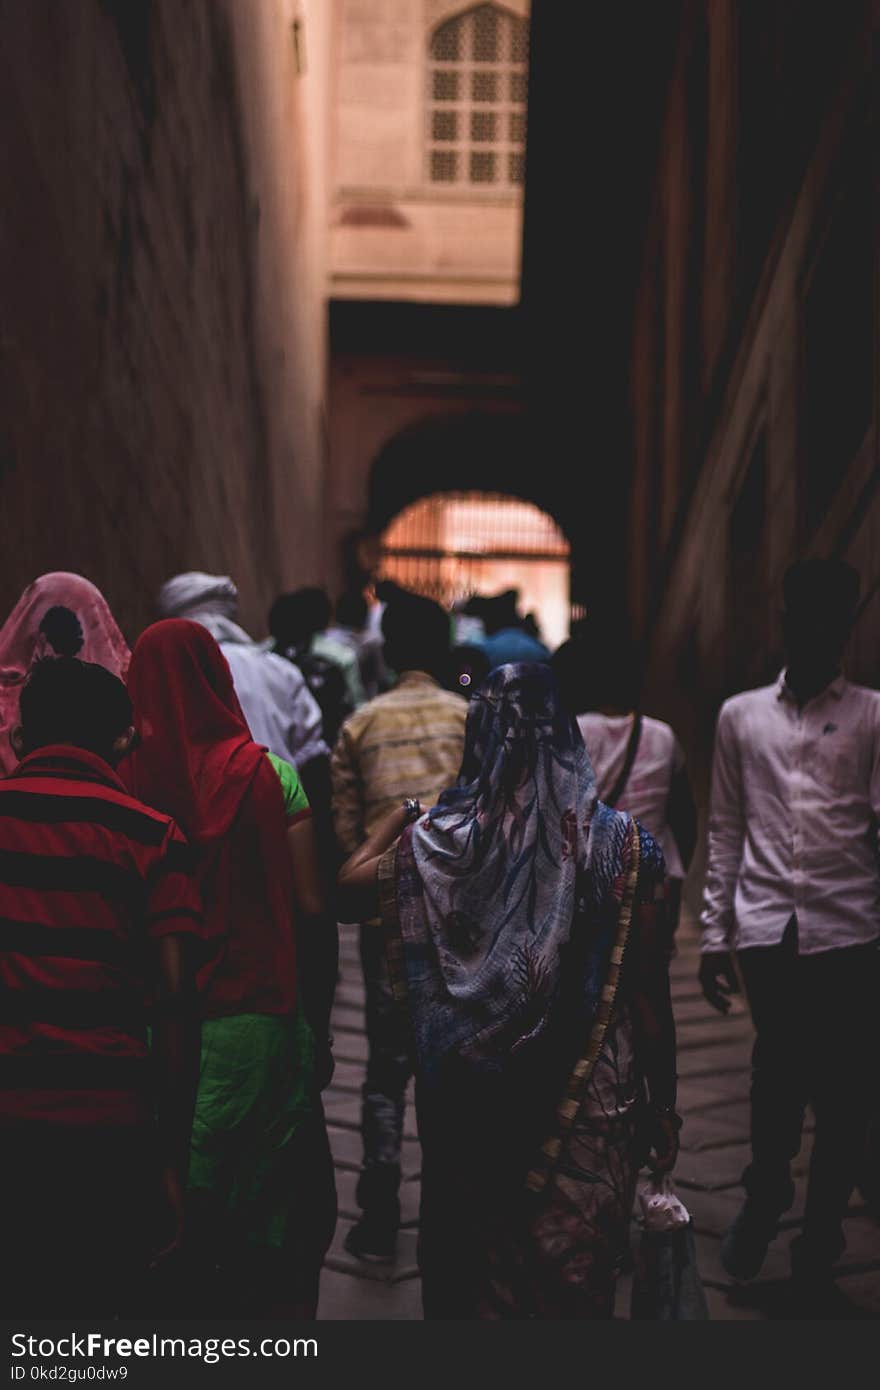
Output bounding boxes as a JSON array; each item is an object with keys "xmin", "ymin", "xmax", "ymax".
[{"xmin": 21, "ymin": 656, "xmax": 132, "ymax": 760}]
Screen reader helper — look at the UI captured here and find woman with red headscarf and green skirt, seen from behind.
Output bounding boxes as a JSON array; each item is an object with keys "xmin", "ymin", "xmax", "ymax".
[{"xmin": 127, "ymin": 620, "xmax": 336, "ymax": 1316}]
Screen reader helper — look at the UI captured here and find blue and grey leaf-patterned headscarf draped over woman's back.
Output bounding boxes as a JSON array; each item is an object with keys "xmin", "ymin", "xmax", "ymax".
[{"xmin": 380, "ymin": 664, "xmax": 645, "ymax": 1077}]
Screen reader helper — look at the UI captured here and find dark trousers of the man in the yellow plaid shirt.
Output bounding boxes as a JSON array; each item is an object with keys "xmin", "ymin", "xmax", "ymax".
[{"xmin": 357, "ymin": 923, "xmax": 413, "ymax": 1211}]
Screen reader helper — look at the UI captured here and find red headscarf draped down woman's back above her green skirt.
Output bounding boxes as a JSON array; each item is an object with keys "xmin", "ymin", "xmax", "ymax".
[{"xmin": 125, "ymin": 619, "xmax": 296, "ymax": 1019}]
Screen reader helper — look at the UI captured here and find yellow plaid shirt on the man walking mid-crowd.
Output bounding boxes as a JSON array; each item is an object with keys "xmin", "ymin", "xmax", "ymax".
[{"xmin": 331, "ymin": 671, "xmax": 467, "ymax": 855}]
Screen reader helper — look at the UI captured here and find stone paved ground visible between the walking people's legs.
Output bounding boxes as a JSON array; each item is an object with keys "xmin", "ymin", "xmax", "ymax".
[{"xmin": 318, "ymin": 924, "xmax": 880, "ymax": 1321}]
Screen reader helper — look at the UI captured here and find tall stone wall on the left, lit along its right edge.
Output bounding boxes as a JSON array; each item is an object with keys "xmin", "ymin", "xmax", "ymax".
[{"xmin": 0, "ymin": 0, "xmax": 328, "ymax": 635}]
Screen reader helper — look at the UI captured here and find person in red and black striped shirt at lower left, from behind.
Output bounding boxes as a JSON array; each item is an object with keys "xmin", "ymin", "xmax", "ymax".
[{"xmin": 0, "ymin": 657, "xmax": 203, "ymax": 1316}]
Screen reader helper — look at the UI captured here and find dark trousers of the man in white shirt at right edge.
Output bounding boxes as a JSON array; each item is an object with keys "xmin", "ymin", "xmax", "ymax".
[{"xmin": 738, "ymin": 917, "xmax": 879, "ymax": 1266}]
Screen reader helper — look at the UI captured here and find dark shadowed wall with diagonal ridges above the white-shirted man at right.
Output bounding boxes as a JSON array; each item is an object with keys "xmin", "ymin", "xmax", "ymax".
[{"xmin": 630, "ymin": 0, "xmax": 880, "ymax": 887}]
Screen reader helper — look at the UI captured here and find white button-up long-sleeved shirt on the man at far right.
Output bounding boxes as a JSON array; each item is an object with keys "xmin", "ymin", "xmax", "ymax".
[{"xmin": 701, "ymin": 673, "xmax": 880, "ymax": 955}]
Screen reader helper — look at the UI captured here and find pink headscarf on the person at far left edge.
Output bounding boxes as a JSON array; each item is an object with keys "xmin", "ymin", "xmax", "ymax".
[{"xmin": 0, "ymin": 571, "xmax": 129, "ymax": 773}]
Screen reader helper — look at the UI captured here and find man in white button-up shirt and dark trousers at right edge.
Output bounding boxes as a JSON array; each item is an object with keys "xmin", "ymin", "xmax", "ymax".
[{"xmin": 699, "ymin": 560, "xmax": 880, "ymax": 1307}]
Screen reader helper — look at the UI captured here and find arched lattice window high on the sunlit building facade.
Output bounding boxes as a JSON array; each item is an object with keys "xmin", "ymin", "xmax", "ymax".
[{"xmin": 427, "ymin": 4, "xmax": 528, "ymax": 189}]
